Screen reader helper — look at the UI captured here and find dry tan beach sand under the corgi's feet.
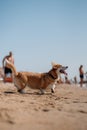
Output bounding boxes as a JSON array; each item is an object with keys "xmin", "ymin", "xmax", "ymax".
[{"xmin": 0, "ymin": 83, "xmax": 87, "ymax": 130}]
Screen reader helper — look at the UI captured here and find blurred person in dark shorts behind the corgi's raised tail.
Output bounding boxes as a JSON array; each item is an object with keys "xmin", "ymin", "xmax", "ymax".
[{"xmin": 2, "ymin": 52, "xmax": 14, "ymax": 80}]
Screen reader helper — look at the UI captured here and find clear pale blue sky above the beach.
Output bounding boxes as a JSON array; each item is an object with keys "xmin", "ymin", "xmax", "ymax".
[{"xmin": 0, "ymin": 0, "xmax": 87, "ymax": 78}]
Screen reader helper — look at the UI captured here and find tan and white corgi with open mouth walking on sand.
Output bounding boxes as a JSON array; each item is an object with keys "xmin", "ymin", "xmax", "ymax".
[{"xmin": 7, "ymin": 61, "xmax": 67, "ymax": 94}]
